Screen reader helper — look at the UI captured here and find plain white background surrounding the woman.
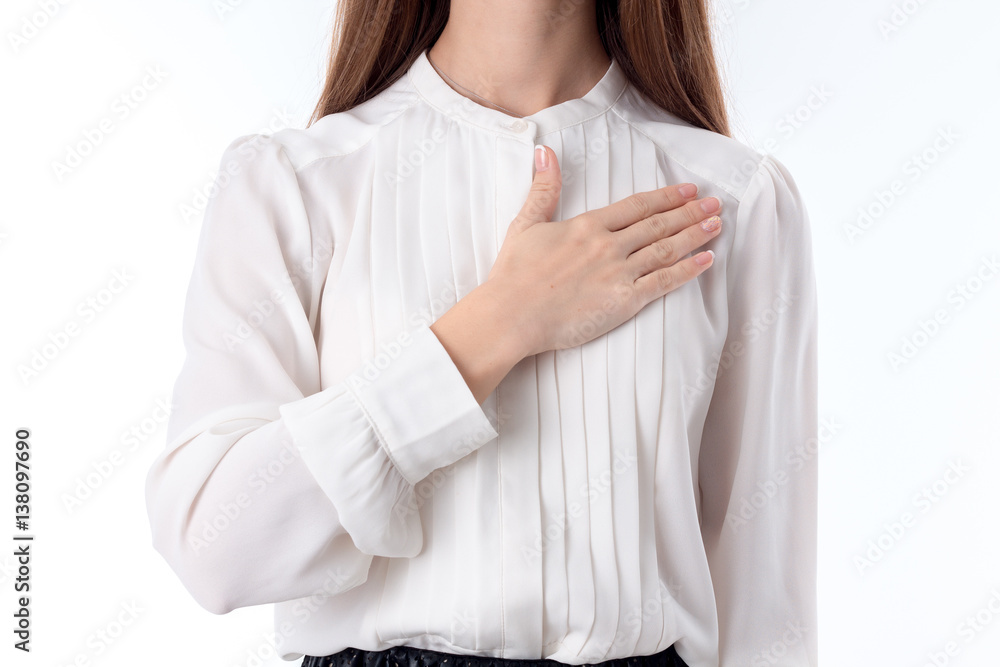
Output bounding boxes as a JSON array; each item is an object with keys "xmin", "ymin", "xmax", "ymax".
[{"xmin": 0, "ymin": 0, "xmax": 1000, "ymax": 667}]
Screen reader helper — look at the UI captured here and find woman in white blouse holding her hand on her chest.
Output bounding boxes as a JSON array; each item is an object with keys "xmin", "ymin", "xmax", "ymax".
[{"xmin": 147, "ymin": 0, "xmax": 817, "ymax": 667}]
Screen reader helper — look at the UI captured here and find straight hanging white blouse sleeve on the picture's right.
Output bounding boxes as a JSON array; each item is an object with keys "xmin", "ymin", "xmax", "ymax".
[{"xmin": 698, "ymin": 155, "xmax": 818, "ymax": 667}]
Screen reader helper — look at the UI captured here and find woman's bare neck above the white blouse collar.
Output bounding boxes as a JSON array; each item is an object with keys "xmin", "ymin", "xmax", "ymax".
[{"xmin": 428, "ymin": 0, "xmax": 611, "ymax": 116}]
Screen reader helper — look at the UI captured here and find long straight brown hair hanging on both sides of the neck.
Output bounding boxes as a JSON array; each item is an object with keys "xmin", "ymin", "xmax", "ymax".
[{"xmin": 309, "ymin": 0, "xmax": 730, "ymax": 136}]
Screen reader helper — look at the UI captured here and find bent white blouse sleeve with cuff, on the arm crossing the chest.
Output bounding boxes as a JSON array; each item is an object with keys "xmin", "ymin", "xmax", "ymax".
[{"xmin": 145, "ymin": 135, "xmax": 497, "ymax": 614}]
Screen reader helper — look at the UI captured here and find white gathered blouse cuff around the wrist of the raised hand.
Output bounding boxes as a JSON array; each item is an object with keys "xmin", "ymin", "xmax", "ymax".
[{"xmin": 278, "ymin": 325, "xmax": 498, "ymax": 557}]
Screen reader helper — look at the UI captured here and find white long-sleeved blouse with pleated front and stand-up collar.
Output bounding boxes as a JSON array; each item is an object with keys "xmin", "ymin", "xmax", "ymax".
[{"xmin": 146, "ymin": 48, "xmax": 818, "ymax": 667}]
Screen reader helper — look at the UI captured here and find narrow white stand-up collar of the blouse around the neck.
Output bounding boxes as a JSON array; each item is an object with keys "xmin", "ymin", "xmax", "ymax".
[{"xmin": 407, "ymin": 50, "xmax": 628, "ymax": 143}]
